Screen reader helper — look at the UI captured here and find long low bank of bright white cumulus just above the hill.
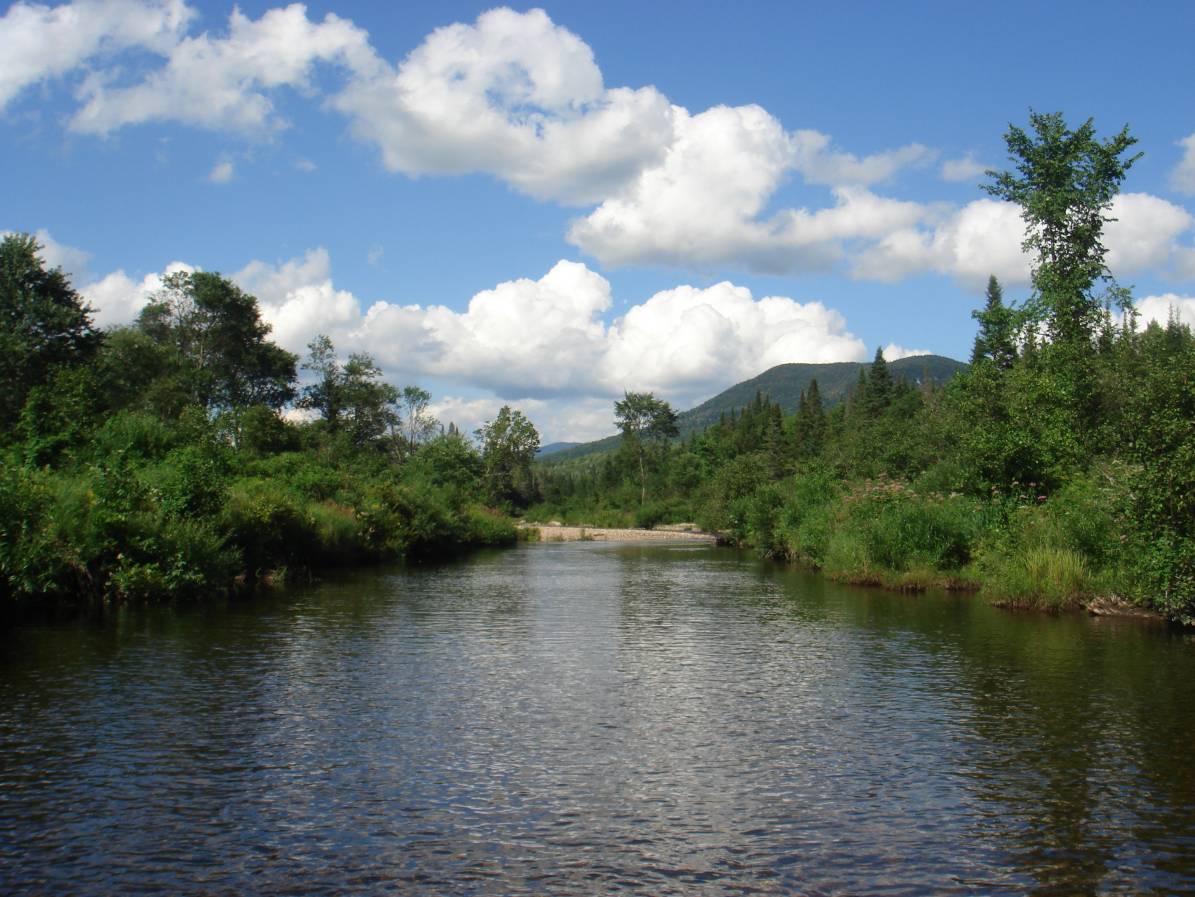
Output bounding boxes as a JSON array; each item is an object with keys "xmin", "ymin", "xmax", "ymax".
[{"xmin": 233, "ymin": 250, "xmax": 866, "ymax": 399}]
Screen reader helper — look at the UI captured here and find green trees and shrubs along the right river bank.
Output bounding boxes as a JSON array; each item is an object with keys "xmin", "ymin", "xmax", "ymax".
[{"xmin": 531, "ymin": 113, "xmax": 1195, "ymax": 623}]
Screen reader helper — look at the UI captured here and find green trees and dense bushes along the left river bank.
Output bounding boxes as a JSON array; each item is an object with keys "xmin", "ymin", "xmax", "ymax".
[{"xmin": 0, "ymin": 234, "xmax": 539, "ymax": 601}]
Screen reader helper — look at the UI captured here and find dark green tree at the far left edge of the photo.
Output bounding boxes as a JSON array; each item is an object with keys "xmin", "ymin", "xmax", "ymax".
[{"xmin": 0, "ymin": 234, "xmax": 102, "ymax": 430}]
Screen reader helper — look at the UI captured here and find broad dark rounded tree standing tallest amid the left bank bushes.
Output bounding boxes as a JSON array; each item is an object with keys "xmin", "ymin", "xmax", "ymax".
[{"xmin": 137, "ymin": 271, "xmax": 298, "ymax": 412}]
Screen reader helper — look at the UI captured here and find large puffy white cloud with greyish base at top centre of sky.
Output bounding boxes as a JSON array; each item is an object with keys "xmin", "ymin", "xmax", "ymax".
[{"xmin": 333, "ymin": 8, "xmax": 673, "ymax": 203}]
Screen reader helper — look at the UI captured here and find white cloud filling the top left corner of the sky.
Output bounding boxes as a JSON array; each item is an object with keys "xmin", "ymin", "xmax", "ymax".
[{"xmin": 0, "ymin": 0, "xmax": 195, "ymax": 110}]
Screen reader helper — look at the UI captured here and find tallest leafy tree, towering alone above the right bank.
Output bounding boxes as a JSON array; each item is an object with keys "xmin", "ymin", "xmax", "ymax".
[{"xmin": 983, "ymin": 111, "xmax": 1141, "ymax": 344}]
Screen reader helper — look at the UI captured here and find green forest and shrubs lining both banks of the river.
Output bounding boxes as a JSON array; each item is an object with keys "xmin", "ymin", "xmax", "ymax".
[{"xmin": 7, "ymin": 113, "xmax": 1195, "ymax": 622}]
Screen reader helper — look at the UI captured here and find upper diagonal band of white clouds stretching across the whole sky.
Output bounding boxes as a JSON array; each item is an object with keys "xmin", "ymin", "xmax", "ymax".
[{"xmin": 9, "ymin": 0, "xmax": 1195, "ymax": 287}]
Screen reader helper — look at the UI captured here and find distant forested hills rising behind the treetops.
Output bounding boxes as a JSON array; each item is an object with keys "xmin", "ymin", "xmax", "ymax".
[{"xmin": 540, "ymin": 355, "xmax": 967, "ymax": 463}]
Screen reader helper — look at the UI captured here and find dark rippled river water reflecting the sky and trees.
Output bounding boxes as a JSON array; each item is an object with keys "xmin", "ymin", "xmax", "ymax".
[{"xmin": 0, "ymin": 542, "xmax": 1195, "ymax": 896}]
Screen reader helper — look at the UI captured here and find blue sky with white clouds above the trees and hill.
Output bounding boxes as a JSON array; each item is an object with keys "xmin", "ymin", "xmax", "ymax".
[{"xmin": 0, "ymin": 0, "xmax": 1195, "ymax": 443}]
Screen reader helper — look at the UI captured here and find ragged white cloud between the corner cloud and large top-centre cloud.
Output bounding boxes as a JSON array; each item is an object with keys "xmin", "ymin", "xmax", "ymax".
[{"xmin": 71, "ymin": 4, "xmax": 381, "ymax": 134}]
